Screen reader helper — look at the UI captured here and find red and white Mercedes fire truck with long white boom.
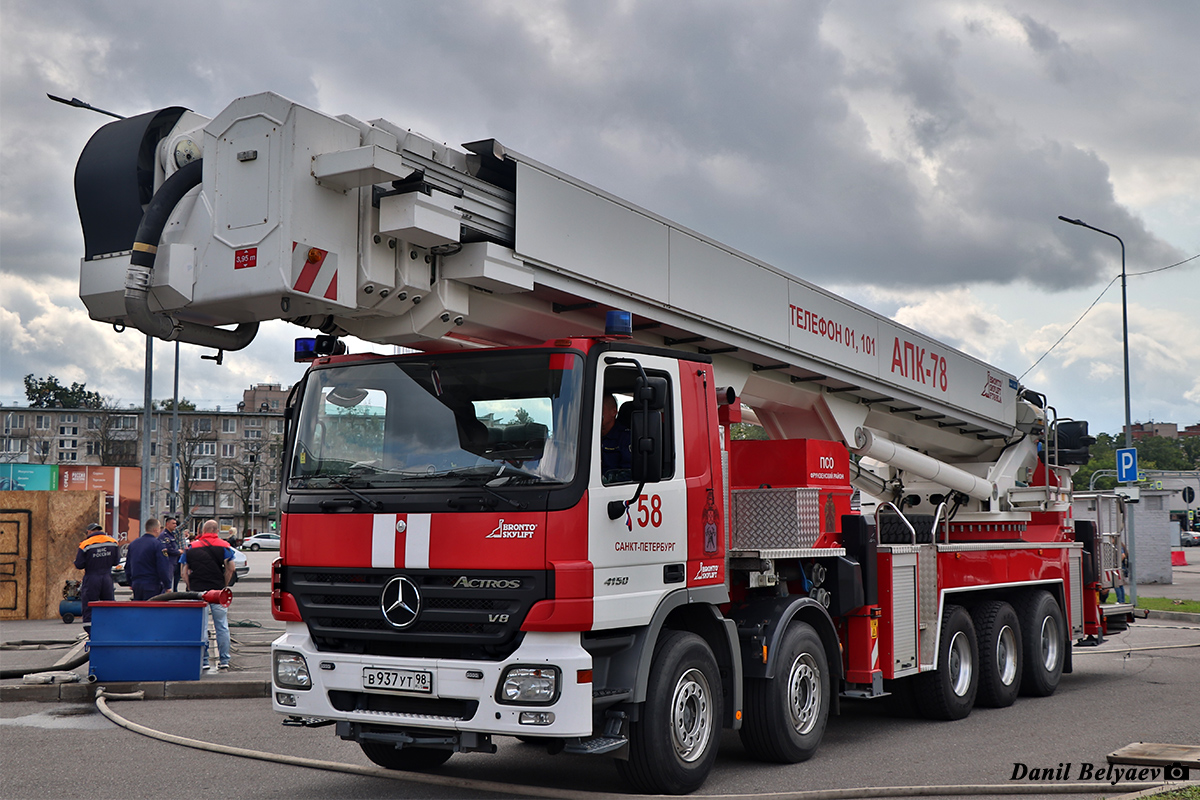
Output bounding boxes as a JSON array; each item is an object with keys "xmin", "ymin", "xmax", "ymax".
[{"xmin": 76, "ymin": 94, "xmax": 1123, "ymax": 793}]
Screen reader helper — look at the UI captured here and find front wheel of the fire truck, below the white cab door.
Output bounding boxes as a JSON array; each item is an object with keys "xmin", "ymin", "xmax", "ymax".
[{"xmin": 617, "ymin": 631, "xmax": 724, "ymax": 794}]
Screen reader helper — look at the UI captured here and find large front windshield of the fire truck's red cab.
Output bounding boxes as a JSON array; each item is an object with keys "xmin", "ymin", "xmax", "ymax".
[{"xmin": 288, "ymin": 351, "xmax": 583, "ymax": 489}]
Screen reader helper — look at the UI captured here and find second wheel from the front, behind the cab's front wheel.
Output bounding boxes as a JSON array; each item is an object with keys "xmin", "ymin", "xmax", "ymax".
[{"xmin": 738, "ymin": 622, "xmax": 829, "ymax": 764}]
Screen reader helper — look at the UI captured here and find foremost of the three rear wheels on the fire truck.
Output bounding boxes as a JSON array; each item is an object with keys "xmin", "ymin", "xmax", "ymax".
[{"xmin": 917, "ymin": 604, "xmax": 979, "ymax": 720}]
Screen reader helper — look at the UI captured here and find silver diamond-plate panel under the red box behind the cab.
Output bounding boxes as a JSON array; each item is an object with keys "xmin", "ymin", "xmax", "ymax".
[{"xmin": 732, "ymin": 488, "xmax": 821, "ymax": 549}]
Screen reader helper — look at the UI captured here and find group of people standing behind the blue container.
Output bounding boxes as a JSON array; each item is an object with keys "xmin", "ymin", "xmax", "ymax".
[{"xmin": 74, "ymin": 517, "xmax": 234, "ymax": 670}]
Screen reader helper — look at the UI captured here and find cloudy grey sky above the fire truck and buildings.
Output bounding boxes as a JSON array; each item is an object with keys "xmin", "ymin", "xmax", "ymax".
[{"xmin": 0, "ymin": 0, "xmax": 1200, "ymax": 432}]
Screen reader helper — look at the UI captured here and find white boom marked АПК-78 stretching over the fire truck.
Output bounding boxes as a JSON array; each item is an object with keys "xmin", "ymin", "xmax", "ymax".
[{"xmin": 80, "ymin": 94, "xmax": 1040, "ymax": 474}]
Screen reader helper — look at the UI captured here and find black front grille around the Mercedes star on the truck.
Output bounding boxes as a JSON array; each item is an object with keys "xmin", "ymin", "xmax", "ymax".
[{"xmin": 283, "ymin": 567, "xmax": 552, "ymax": 661}]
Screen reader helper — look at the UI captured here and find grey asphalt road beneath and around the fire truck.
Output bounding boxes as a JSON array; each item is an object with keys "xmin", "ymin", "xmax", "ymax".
[{"xmin": 0, "ymin": 606, "xmax": 1200, "ymax": 800}]
